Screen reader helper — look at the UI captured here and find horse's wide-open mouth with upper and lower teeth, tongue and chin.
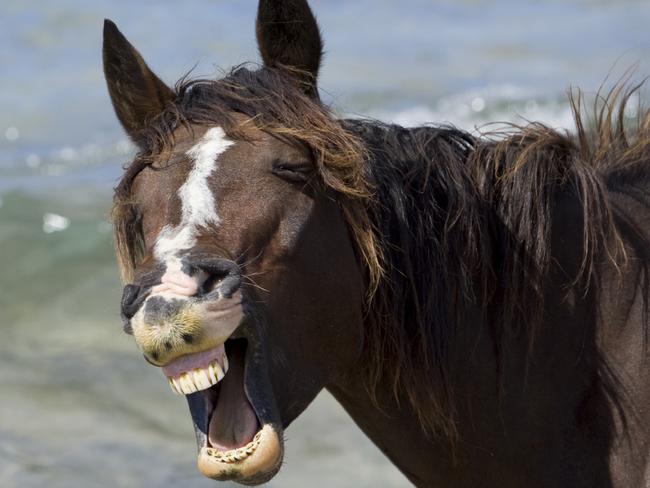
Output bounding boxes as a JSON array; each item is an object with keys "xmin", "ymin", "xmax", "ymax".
[{"xmin": 163, "ymin": 339, "xmax": 283, "ymax": 485}]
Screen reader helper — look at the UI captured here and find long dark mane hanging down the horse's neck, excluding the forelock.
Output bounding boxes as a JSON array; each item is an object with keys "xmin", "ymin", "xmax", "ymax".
[{"xmin": 345, "ymin": 84, "xmax": 650, "ymax": 442}]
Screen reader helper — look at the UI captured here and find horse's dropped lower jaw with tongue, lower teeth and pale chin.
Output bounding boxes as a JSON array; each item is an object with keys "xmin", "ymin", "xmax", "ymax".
[{"xmin": 186, "ymin": 339, "xmax": 284, "ymax": 485}]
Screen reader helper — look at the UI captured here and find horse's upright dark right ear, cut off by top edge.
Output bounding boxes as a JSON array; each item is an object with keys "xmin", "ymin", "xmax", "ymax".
[{"xmin": 256, "ymin": 0, "xmax": 323, "ymax": 93}]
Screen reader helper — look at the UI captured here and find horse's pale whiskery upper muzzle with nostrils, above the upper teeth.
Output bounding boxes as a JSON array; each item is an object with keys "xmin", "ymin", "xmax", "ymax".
[{"xmin": 122, "ymin": 257, "xmax": 244, "ymax": 366}]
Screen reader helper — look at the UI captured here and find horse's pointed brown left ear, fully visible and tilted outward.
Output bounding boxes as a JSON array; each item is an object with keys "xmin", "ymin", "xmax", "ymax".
[{"xmin": 103, "ymin": 19, "xmax": 174, "ymax": 144}]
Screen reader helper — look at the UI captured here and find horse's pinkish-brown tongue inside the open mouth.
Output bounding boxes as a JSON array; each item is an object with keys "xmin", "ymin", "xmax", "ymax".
[{"xmin": 208, "ymin": 348, "xmax": 259, "ymax": 451}]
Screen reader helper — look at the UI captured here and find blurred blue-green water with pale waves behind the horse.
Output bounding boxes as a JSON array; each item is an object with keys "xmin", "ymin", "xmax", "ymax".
[{"xmin": 0, "ymin": 0, "xmax": 650, "ymax": 488}]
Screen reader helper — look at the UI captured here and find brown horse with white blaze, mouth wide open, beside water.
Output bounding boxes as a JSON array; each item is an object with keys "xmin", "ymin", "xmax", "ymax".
[{"xmin": 103, "ymin": 0, "xmax": 650, "ymax": 488}]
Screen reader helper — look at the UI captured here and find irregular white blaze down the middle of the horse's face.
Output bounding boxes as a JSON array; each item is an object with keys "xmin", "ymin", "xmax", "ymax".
[{"xmin": 154, "ymin": 127, "xmax": 234, "ymax": 290}]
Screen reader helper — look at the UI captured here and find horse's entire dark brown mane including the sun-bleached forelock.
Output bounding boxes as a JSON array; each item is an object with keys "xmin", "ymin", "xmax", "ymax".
[{"xmin": 113, "ymin": 66, "xmax": 650, "ymax": 439}]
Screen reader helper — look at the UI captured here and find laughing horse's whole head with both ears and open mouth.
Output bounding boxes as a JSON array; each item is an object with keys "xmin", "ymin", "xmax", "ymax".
[{"xmin": 103, "ymin": 0, "xmax": 366, "ymax": 484}]
